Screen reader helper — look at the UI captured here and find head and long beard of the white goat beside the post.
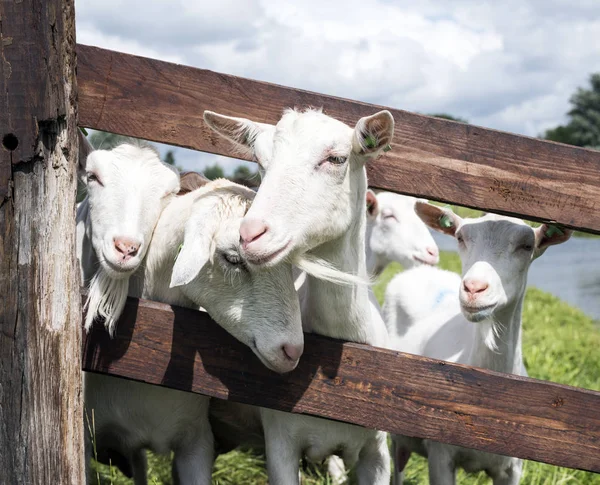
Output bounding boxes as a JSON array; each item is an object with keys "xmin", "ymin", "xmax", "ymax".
[{"xmin": 77, "ymin": 144, "xmax": 179, "ymax": 334}]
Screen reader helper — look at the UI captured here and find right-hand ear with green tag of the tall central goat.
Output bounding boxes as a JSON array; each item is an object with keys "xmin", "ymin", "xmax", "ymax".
[{"xmin": 352, "ymin": 110, "xmax": 394, "ymax": 157}]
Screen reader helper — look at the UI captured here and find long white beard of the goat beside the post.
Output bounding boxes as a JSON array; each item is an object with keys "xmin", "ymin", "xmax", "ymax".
[{"xmin": 85, "ymin": 267, "xmax": 129, "ymax": 337}]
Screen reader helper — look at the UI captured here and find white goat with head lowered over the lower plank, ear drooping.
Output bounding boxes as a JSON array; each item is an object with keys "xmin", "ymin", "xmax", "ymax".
[{"xmin": 85, "ymin": 180, "xmax": 303, "ymax": 485}]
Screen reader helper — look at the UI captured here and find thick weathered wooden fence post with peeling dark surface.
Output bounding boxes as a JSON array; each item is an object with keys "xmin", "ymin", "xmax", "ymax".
[{"xmin": 0, "ymin": 0, "xmax": 85, "ymax": 485}]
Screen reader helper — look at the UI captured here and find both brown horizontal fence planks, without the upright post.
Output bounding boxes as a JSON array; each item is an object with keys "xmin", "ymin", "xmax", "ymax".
[{"xmin": 77, "ymin": 45, "xmax": 600, "ymax": 472}]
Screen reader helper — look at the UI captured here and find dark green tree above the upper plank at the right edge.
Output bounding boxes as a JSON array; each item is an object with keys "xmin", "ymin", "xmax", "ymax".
[{"xmin": 543, "ymin": 73, "xmax": 600, "ymax": 149}]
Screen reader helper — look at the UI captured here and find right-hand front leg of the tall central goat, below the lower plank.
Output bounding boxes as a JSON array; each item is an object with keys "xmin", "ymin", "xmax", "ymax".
[{"xmin": 356, "ymin": 431, "xmax": 391, "ymax": 485}]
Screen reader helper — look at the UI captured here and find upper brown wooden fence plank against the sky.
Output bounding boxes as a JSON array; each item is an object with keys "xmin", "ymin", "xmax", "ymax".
[{"xmin": 78, "ymin": 45, "xmax": 600, "ymax": 233}]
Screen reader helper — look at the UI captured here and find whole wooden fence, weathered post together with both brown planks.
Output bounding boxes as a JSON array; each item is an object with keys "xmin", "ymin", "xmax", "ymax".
[{"xmin": 0, "ymin": 0, "xmax": 600, "ymax": 484}]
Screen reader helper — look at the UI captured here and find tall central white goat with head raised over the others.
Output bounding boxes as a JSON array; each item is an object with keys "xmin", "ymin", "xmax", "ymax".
[{"xmin": 204, "ymin": 110, "xmax": 394, "ymax": 485}]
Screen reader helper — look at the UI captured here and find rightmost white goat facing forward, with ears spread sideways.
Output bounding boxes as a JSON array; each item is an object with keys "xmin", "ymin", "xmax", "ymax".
[{"xmin": 384, "ymin": 202, "xmax": 571, "ymax": 485}]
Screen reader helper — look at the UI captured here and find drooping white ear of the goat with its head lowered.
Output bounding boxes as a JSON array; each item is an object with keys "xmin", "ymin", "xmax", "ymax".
[{"xmin": 169, "ymin": 206, "xmax": 214, "ymax": 288}]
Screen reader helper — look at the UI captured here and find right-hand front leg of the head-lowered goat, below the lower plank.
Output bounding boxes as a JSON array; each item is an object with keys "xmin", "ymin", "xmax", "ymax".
[{"xmin": 171, "ymin": 428, "xmax": 214, "ymax": 485}]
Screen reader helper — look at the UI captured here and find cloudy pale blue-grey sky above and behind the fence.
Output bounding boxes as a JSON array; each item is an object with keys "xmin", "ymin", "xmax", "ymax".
[{"xmin": 75, "ymin": 0, "xmax": 600, "ymax": 174}]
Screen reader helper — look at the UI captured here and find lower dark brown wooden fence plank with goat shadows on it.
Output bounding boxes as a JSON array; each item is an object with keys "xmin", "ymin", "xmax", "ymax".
[{"xmin": 83, "ymin": 298, "xmax": 600, "ymax": 472}]
